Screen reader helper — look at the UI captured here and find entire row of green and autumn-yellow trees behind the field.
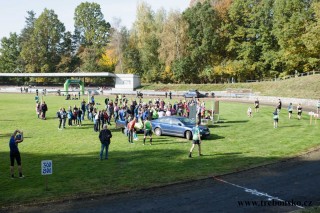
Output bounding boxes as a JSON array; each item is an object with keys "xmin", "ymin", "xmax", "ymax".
[{"xmin": 0, "ymin": 0, "xmax": 320, "ymax": 83}]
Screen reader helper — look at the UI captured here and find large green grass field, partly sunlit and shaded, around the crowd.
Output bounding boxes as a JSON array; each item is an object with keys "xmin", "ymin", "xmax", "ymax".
[{"xmin": 0, "ymin": 94, "xmax": 320, "ymax": 206}]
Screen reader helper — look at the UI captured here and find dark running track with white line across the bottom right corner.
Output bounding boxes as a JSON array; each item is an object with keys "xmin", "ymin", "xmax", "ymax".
[{"xmin": 7, "ymin": 151, "xmax": 320, "ymax": 213}]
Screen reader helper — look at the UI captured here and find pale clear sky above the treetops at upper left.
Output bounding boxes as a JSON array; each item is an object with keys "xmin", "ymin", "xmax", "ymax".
[{"xmin": 0, "ymin": 0, "xmax": 190, "ymax": 39}]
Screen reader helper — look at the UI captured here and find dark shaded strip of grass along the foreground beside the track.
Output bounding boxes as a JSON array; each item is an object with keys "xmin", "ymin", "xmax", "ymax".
[{"xmin": 0, "ymin": 146, "xmax": 312, "ymax": 209}]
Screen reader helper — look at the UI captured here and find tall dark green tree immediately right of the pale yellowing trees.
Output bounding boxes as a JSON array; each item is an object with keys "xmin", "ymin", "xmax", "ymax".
[{"xmin": 181, "ymin": 1, "xmax": 223, "ymax": 82}]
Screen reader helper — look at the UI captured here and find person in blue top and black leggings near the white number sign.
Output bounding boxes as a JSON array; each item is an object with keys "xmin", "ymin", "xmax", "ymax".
[{"xmin": 9, "ymin": 129, "xmax": 24, "ymax": 178}]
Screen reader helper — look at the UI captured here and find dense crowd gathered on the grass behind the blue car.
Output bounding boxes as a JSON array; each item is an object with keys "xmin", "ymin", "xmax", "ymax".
[{"xmin": 52, "ymin": 95, "xmax": 211, "ymax": 158}]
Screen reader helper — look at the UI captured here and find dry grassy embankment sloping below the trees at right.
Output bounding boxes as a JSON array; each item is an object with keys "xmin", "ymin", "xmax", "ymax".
[{"xmin": 142, "ymin": 75, "xmax": 320, "ymax": 99}]
